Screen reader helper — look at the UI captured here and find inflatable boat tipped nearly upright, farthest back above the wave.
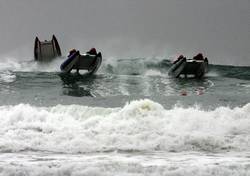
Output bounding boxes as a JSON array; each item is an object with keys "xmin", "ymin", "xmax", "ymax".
[{"xmin": 34, "ymin": 35, "xmax": 62, "ymax": 61}]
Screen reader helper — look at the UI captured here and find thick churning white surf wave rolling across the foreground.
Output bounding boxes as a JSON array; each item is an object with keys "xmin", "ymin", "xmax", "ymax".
[{"xmin": 0, "ymin": 100, "xmax": 250, "ymax": 153}]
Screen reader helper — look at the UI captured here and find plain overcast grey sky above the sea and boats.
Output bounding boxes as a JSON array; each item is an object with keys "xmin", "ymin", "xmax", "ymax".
[{"xmin": 0, "ymin": 0, "xmax": 250, "ymax": 65}]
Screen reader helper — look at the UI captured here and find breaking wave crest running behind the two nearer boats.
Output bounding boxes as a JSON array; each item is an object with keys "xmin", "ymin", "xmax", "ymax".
[{"xmin": 0, "ymin": 57, "xmax": 250, "ymax": 80}]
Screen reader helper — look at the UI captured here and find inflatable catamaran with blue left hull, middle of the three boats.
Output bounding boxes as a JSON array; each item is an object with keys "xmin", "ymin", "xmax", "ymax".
[{"xmin": 60, "ymin": 51, "xmax": 102, "ymax": 74}]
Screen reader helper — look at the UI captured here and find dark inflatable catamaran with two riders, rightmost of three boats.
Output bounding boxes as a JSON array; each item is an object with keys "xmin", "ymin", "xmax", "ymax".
[{"xmin": 168, "ymin": 57, "xmax": 208, "ymax": 78}]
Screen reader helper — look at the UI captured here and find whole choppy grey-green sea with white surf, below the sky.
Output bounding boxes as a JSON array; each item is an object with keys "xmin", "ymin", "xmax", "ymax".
[{"xmin": 0, "ymin": 58, "xmax": 250, "ymax": 176}]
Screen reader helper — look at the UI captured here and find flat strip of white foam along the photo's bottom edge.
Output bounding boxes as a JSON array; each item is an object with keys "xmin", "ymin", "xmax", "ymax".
[{"xmin": 0, "ymin": 152, "xmax": 250, "ymax": 176}]
